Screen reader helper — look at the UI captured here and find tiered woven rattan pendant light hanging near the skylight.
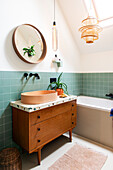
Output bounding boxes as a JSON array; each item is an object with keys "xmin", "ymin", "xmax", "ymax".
[{"xmin": 79, "ymin": 0, "xmax": 102, "ymax": 43}]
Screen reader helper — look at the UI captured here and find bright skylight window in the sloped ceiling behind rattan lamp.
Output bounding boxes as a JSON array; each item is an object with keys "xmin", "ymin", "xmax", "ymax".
[{"xmin": 84, "ymin": 0, "xmax": 113, "ymax": 27}]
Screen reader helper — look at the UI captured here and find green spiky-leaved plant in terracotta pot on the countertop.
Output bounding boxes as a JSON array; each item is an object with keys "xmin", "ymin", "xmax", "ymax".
[{"xmin": 47, "ymin": 72, "xmax": 68, "ymax": 95}]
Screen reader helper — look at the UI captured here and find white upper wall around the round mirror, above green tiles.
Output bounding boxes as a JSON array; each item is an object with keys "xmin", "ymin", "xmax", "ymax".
[{"xmin": 0, "ymin": 0, "xmax": 81, "ymax": 72}]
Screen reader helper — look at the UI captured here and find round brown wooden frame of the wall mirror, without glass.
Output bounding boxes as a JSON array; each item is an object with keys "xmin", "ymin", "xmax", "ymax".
[{"xmin": 12, "ymin": 24, "xmax": 47, "ymax": 64}]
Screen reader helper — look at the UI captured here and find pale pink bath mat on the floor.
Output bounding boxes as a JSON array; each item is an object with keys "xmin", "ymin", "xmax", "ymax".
[{"xmin": 48, "ymin": 144, "xmax": 107, "ymax": 170}]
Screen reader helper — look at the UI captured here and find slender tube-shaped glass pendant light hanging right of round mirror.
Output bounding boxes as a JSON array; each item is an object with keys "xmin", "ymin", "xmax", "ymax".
[{"xmin": 52, "ymin": 0, "xmax": 58, "ymax": 51}]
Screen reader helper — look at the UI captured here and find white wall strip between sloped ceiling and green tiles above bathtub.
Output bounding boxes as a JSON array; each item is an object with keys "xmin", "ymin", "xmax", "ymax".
[{"xmin": 81, "ymin": 51, "xmax": 113, "ymax": 73}]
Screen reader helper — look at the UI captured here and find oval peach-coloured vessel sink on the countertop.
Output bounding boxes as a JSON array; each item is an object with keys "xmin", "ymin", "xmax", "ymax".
[{"xmin": 21, "ymin": 90, "xmax": 58, "ymax": 104}]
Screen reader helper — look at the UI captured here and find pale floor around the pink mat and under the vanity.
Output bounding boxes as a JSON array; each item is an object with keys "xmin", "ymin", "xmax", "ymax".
[{"xmin": 22, "ymin": 134, "xmax": 113, "ymax": 170}]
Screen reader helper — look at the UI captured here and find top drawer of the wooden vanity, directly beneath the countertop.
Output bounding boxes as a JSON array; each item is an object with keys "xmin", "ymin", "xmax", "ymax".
[{"xmin": 29, "ymin": 101, "xmax": 76, "ymax": 126}]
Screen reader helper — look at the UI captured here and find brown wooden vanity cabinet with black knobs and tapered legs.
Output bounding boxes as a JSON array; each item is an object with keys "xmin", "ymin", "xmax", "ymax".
[{"xmin": 12, "ymin": 100, "xmax": 77, "ymax": 164}]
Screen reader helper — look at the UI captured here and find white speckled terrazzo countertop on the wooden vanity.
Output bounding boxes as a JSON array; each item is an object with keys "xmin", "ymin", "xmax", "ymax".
[{"xmin": 10, "ymin": 95, "xmax": 77, "ymax": 112}]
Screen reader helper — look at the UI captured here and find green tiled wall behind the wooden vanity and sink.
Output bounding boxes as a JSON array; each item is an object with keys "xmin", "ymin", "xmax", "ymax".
[{"xmin": 0, "ymin": 71, "xmax": 82, "ymax": 150}]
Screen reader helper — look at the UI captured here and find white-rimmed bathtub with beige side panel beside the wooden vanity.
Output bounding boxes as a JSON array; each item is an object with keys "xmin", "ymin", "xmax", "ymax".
[{"xmin": 73, "ymin": 96, "xmax": 113, "ymax": 148}]
